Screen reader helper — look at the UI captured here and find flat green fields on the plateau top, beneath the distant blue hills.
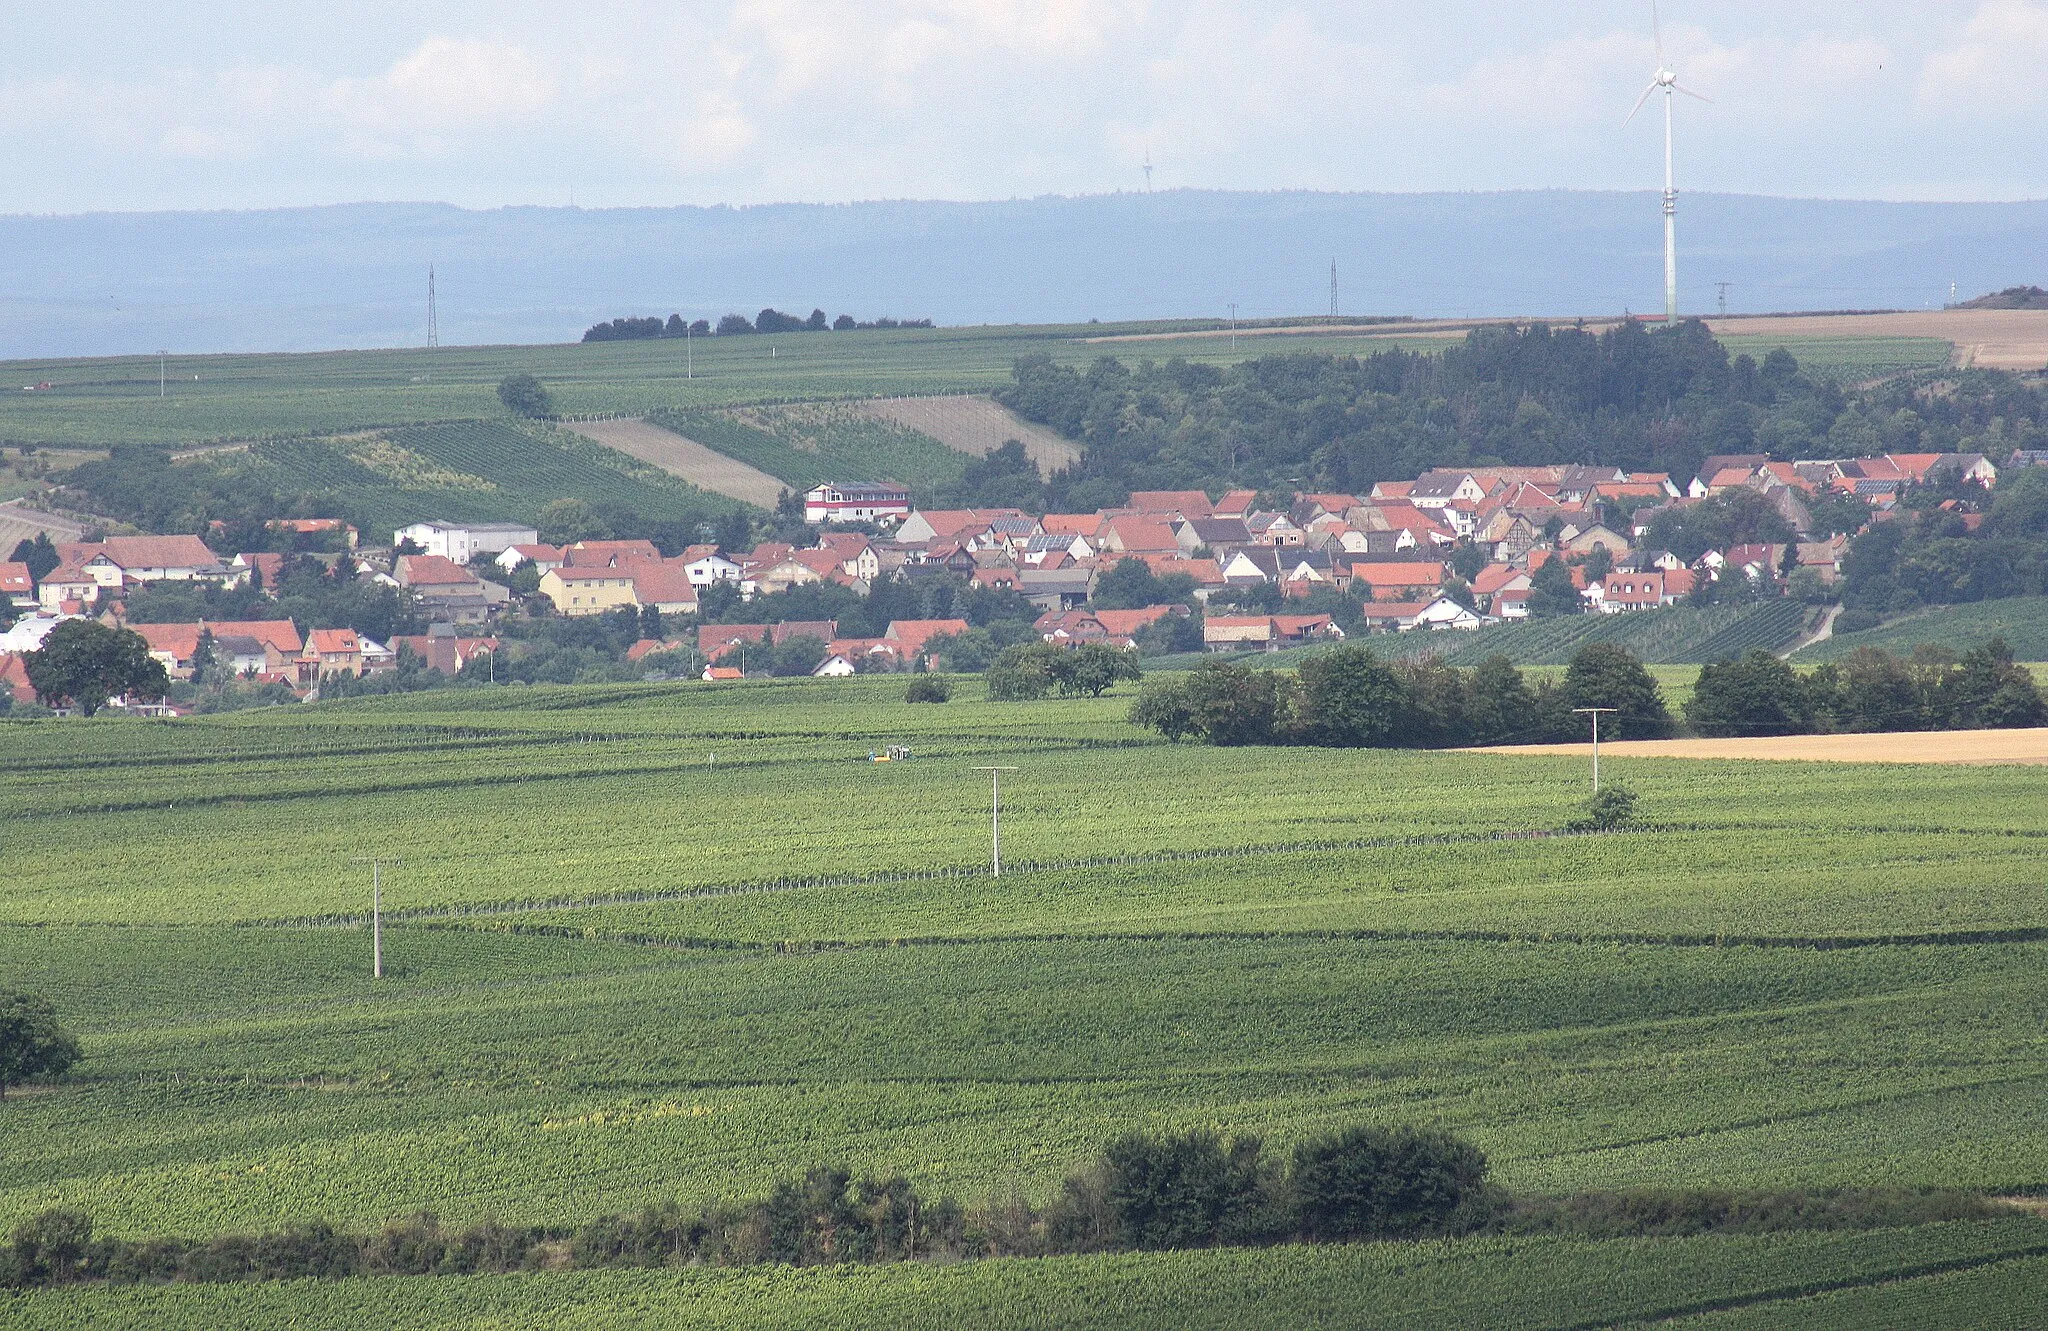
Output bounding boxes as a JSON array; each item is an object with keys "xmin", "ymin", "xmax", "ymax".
[{"xmin": 0, "ymin": 324, "xmax": 1948, "ymax": 446}]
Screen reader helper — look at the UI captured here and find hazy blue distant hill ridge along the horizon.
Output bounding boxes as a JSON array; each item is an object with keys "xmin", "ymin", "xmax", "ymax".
[{"xmin": 0, "ymin": 190, "xmax": 2048, "ymax": 358}]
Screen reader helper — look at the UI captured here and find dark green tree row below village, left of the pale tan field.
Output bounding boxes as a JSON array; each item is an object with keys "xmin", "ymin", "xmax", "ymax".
[{"xmin": 1130, "ymin": 643, "xmax": 1671, "ymax": 747}]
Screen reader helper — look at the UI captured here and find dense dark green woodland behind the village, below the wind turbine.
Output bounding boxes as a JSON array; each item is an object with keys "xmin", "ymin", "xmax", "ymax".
[{"xmin": 997, "ymin": 321, "xmax": 2048, "ymax": 513}]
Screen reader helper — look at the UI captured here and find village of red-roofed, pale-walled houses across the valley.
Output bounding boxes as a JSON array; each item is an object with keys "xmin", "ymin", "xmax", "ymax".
[{"xmin": 0, "ymin": 453, "xmax": 2007, "ymax": 711}]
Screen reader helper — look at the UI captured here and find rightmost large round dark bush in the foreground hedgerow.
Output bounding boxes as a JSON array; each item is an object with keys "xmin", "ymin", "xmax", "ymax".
[{"xmin": 1288, "ymin": 1128, "xmax": 1487, "ymax": 1241}]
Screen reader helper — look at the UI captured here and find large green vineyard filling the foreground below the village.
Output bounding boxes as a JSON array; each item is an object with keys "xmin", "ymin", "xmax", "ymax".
[{"xmin": 0, "ymin": 678, "xmax": 2048, "ymax": 1327}]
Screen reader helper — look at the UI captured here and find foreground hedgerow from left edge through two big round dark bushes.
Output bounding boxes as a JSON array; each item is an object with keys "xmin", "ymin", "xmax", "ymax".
[{"xmin": 0, "ymin": 1128, "xmax": 1497, "ymax": 1288}]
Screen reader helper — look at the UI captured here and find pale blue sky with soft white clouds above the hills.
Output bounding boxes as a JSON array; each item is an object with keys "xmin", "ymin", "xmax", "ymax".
[{"xmin": 0, "ymin": 0, "xmax": 2048, "ymax": 213}]
